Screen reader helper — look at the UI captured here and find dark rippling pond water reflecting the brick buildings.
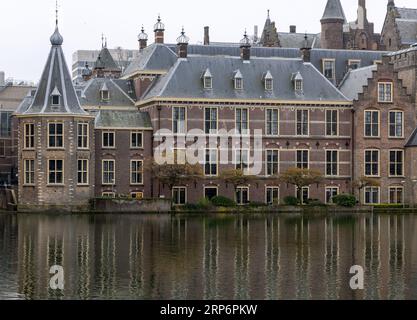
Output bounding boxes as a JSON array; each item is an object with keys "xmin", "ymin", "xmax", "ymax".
[{"xmin": 0, "ymin": 215, "xmax": 417, "ymax": 299}]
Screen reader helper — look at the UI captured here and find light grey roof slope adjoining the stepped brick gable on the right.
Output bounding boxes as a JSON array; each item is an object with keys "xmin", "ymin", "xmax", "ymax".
[{"xmin": 339, "ymin": 65, "xmax": 377, "ymax": 100}]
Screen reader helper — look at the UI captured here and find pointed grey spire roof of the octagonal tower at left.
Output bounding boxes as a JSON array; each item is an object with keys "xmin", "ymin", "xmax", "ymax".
[{"xmin": 18, "ymin": 27, "xmax": 87, "ymax": 115}]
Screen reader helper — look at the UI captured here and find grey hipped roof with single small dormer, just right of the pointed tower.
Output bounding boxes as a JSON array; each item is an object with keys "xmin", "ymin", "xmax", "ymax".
[{"xmin": 77, "ymin": 78, "xmax": 136, "ymax": 107}]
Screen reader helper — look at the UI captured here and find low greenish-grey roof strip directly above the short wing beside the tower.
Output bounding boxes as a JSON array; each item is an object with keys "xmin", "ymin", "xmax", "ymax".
[{"xmin": 95, "ymin": 110, "xmax": 152, "ymax": 129}]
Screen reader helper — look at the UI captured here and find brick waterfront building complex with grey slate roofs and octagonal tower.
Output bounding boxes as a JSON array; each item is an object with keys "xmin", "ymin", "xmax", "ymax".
[{"xmin": 10, "ymin": 10, "xmax": 417, "ymax": 208}]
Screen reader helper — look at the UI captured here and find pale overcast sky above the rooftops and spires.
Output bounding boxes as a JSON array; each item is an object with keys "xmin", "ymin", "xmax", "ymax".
[{"xmin": 0, "ymin": 0, "xmax": 417, "ymax": 81}]
